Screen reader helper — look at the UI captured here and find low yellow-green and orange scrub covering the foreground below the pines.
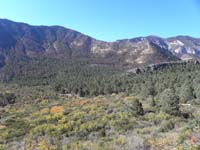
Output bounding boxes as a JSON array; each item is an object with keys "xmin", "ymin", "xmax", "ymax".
[{"xmin": 0, "ymin": 89, "xmax": 200, "ymax": 150}]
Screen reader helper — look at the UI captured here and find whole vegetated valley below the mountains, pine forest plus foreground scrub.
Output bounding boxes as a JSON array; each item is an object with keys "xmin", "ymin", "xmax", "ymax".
[{"xmin": 0, "ymin": 57, "xmax": 200, "ymax": 150}]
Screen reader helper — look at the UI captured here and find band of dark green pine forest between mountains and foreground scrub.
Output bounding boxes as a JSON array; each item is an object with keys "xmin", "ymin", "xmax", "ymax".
[{"xmin": 0, "ymin": 57, "xmax": 200, "ymax": 99}]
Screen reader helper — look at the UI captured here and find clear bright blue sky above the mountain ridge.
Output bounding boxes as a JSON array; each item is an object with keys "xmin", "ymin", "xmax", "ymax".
[{"xmin": 0, "ymin": 0, "xmax": 200, "ymax": 41}]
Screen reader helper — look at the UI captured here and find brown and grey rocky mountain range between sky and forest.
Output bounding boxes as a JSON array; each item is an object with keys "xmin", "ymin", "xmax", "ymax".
[{"xmin": 0, "ymin": 19, "xmax": 200, "ymax": 66}]
